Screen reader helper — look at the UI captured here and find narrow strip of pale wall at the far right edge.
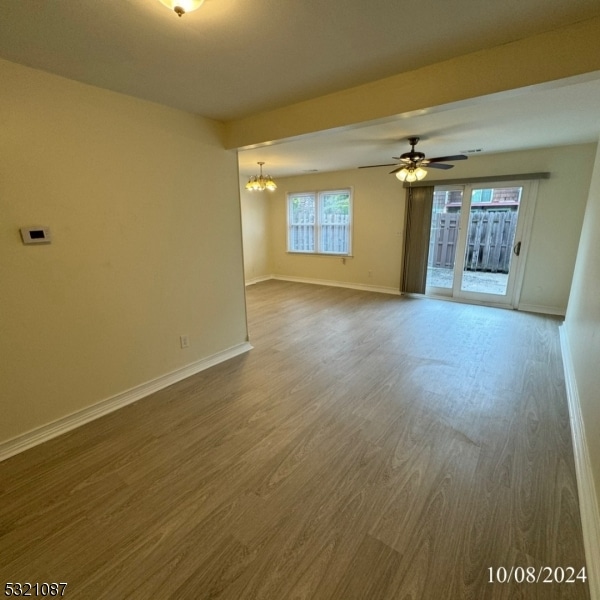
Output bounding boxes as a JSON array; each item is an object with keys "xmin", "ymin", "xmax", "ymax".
[{"xmin": 565, "ymin": 139, "xmax": 600, "ymax": 510}]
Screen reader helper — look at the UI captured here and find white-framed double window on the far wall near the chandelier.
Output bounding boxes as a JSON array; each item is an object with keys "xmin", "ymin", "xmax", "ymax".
[{"xmin": 287, "ymin": 189, "xmax": 352, "ymax": 256}]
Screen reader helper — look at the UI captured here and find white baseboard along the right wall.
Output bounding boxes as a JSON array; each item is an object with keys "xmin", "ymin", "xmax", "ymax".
[{"xmin": 559, "ymin": 325, "xmax": 600, "ymax": 600}]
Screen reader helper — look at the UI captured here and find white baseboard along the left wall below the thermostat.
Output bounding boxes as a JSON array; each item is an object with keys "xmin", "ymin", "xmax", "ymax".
[{"xmin": 0, "ymin": 342, "xmax": 252, "ymax": 461}]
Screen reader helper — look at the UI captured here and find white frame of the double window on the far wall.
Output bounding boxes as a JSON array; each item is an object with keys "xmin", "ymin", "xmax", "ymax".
[{"xmin": 286, "ymin": 186, "xmax": 354, "ymax": 258}]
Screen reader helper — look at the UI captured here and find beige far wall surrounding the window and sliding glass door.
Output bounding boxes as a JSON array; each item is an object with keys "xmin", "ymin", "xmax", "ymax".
[{"xmin": 244, "ymin": 144, "xmax": 596, "ymax": 314}]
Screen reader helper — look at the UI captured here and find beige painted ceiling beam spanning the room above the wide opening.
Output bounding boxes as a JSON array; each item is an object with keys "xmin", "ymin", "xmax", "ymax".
[{"xmin": 224, "ymin": 18, "xmax": 600, "ymax": 148}]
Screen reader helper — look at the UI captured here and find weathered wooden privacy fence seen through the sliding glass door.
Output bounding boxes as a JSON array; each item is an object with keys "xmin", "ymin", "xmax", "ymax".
[{"xmin": 429, "ymin": 210, "xmax": 518, "ymax": 273}]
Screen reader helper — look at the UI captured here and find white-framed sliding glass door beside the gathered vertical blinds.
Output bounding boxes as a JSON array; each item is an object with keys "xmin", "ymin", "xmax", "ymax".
[{"xmin": 426, "ymin": 182, "xmax": 535, "ymax": 306}]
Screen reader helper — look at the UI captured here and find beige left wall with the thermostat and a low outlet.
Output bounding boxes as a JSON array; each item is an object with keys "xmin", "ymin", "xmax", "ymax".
[{"xmin": 0, "ymin": 61, "xmax": 247, "ymax": 441}]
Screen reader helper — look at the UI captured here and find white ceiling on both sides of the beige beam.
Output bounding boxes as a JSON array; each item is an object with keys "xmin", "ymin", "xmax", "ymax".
[{"xmin": 0, "ymin": 0, "xmax": 600, "ymax": 176}]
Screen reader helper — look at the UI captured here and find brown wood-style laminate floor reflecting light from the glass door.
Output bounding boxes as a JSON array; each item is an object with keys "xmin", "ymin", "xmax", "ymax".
[{"xmin": 0, "ymin": 281, "xmax": 589, "ymax": 600}]
